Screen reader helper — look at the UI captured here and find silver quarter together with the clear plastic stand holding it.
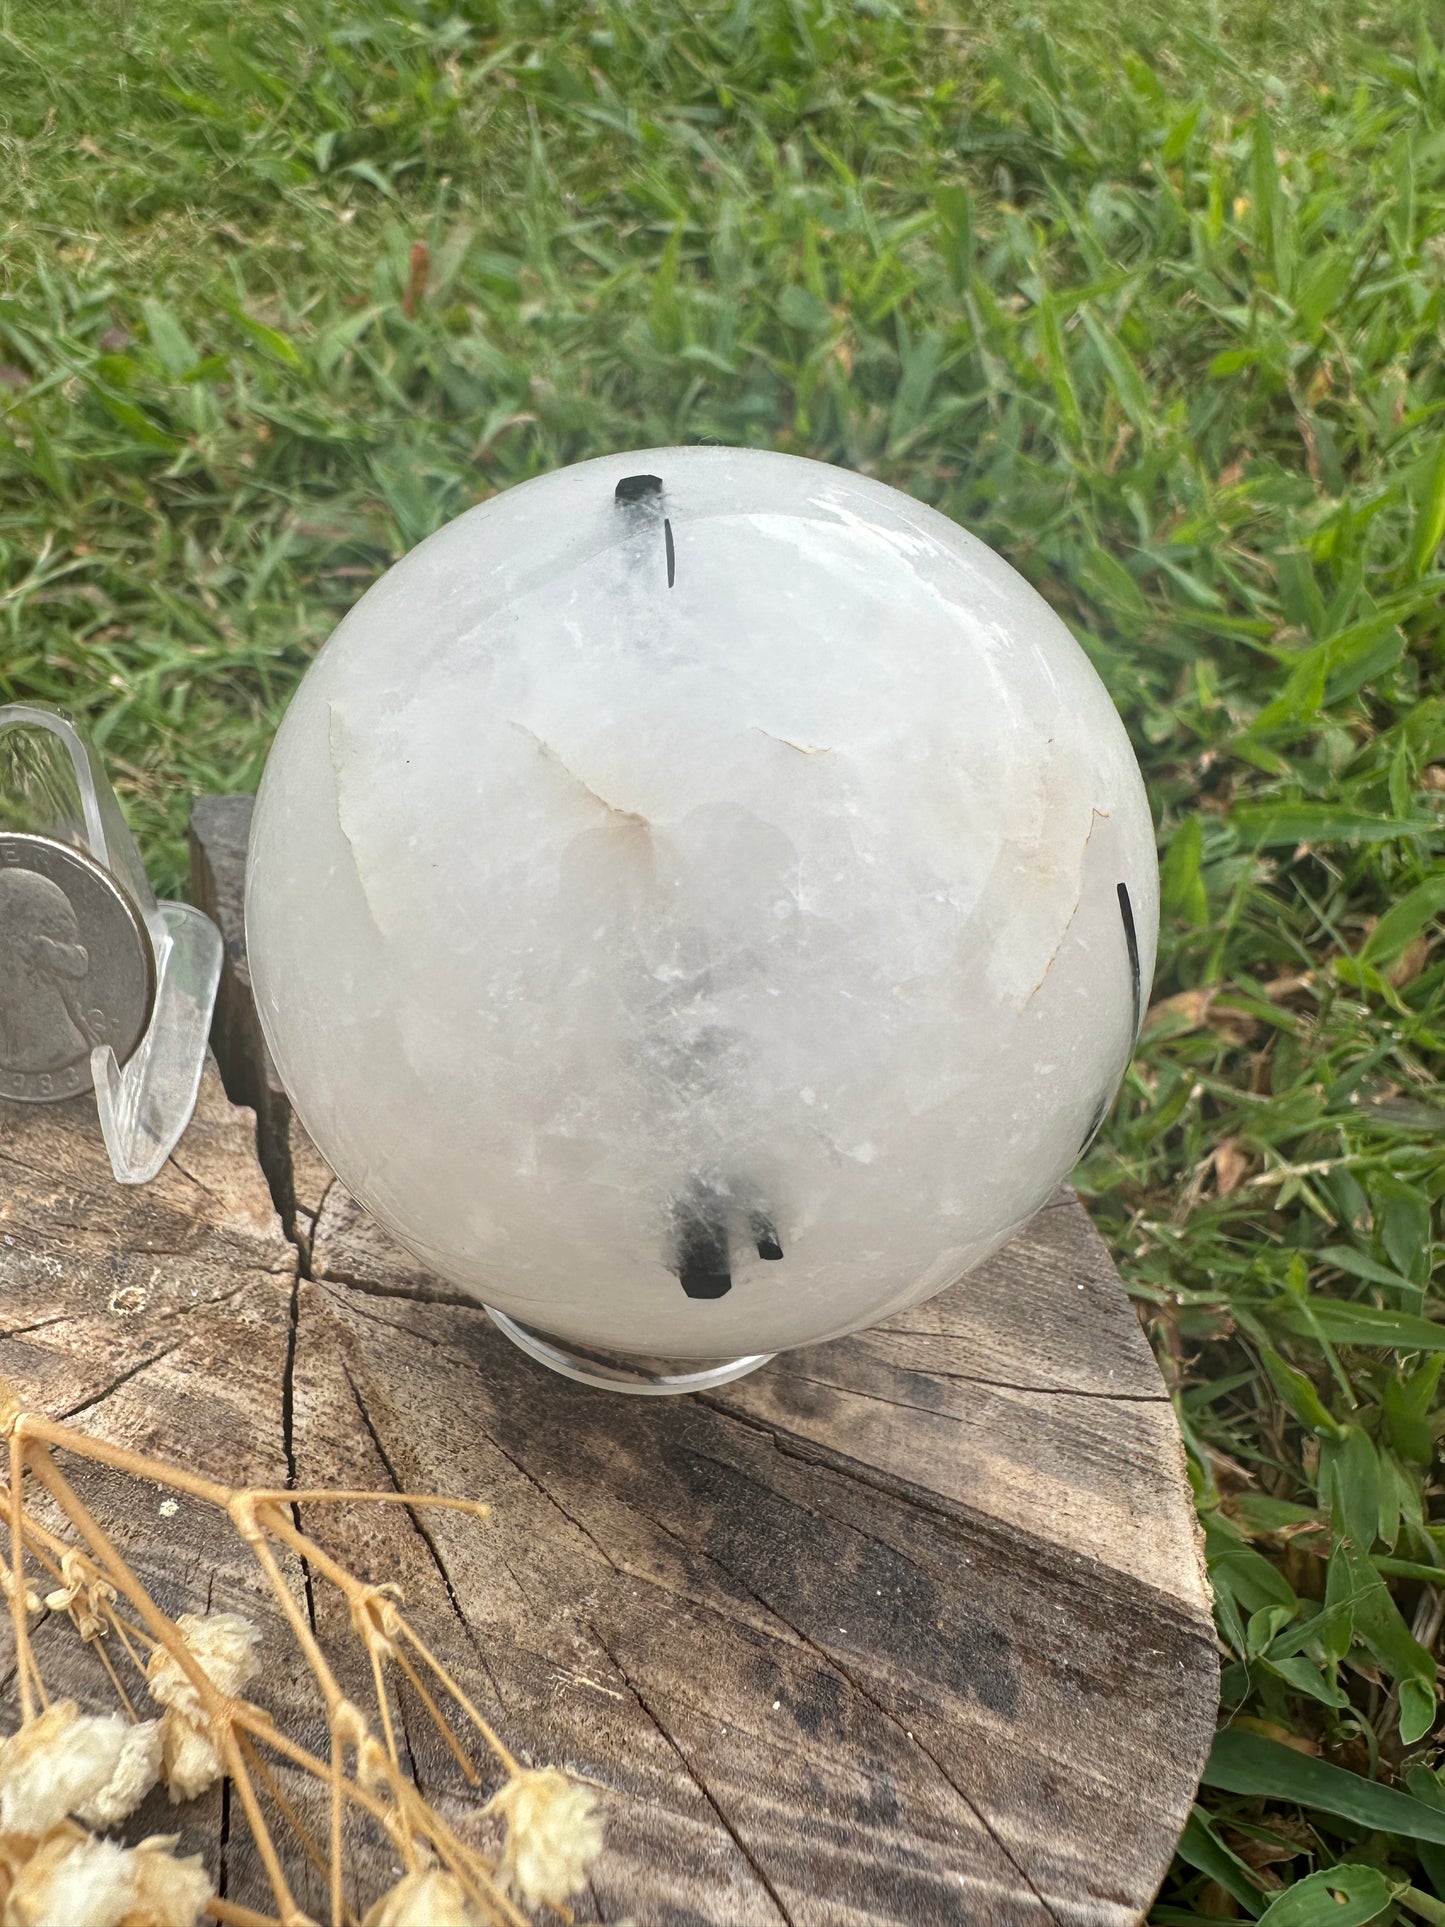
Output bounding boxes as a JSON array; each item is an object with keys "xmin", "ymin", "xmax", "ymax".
[{"xmin": 0, "ymin": 703, "xmax": 222, "ymax": 1185}]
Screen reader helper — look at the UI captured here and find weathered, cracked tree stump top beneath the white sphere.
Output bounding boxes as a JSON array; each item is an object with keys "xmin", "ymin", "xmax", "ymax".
[{"xmin": 0, "ymin": 798, "xmax": 1218, "ymax": 1927}]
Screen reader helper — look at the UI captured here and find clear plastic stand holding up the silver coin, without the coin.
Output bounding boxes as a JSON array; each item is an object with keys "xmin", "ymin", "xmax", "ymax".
[{"xmin": 0, "ymin": 703, "xmax": 222, "ymax": 1185}]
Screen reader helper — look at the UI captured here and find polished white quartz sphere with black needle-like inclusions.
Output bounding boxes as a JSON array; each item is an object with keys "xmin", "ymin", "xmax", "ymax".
[{"xmin": 247, "ymin": 447, "xmax": 1158, "ymax": 1360}]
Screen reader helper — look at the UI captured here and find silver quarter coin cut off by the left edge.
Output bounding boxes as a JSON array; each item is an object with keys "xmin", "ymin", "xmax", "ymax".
[{"xmin": 0, "ymin": 831, "xmax": 156, "ymax": 1104}]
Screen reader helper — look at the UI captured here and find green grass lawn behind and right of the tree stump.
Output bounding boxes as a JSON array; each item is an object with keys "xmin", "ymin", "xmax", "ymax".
[{"xmin": 0, "ymin": 0, "xmax": 1445, "ymax": 1927}]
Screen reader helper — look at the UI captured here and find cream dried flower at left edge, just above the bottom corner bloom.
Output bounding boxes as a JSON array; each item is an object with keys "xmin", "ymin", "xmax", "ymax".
[{"xmin": 0, "ymin": 1700, "xmax": 160, "ymax": 1833}]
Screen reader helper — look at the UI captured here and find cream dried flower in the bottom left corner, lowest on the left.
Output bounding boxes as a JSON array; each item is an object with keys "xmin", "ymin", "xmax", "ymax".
[{"xmin": 4, "ymin": 1825, "xmax": 212, "ymax": 1927}]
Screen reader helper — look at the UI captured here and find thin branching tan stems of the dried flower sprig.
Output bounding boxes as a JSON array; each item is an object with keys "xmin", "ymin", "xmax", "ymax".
[{"xmin": 0, "ymin": 1386, "xmax": 599, "ymax": 1927}]
